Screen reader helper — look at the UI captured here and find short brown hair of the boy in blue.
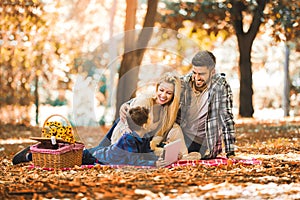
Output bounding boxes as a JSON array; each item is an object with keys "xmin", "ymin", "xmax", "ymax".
[{"xmin": 127, "ymin": 106, "xmax": 149, "ymax": 131}]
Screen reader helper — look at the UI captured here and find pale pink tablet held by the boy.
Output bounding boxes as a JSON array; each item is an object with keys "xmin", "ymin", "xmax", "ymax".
[{"xmin": 163, "ymin": 139, "xmax": 181, "ymax": 165}]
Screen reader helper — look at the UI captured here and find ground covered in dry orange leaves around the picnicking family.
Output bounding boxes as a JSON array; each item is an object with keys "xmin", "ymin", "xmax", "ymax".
[{"xmin": 0, "ymin": 118, "xmax": 300, "ymax": 199}]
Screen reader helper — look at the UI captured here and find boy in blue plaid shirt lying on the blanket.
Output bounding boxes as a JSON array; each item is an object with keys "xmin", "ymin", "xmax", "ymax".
[{"xmin": 87, "ymin": 106, "xmax": 167, "ymax": 167}]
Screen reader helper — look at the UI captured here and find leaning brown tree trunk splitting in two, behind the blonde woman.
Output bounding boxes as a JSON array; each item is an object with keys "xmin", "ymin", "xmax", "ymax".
[{"xmin": 116, "ymin": 0, "xmax": 158, "ymax": 118}]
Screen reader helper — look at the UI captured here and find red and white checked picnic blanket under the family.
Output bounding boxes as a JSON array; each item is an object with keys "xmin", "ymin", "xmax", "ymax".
[{"xmin": 29, "ymin": 157, "xmax": 262, "ymax": 171}]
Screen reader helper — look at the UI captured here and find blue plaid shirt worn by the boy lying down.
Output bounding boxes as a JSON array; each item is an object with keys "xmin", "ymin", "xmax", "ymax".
[{"xmin": 92, "ymin": 132, "xmax": 158, "ymax": 166}]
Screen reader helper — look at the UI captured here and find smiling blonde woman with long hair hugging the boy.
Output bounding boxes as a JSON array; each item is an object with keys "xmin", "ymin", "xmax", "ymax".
[{"xmin": 111, "ymin": 72, "xmax": 188, "ymax": 155}]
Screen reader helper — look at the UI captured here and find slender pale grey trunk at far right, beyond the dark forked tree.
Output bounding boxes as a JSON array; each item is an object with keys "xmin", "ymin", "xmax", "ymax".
[{"xmin": 282, "ymin": 44, "xmax": 290, "ymax": 117}]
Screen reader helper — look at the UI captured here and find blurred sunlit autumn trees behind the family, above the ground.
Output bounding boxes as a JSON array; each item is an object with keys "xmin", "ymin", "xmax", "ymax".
[{"xmin": 0, "ymin": 0, "xmax": 300, "ymax": 126}]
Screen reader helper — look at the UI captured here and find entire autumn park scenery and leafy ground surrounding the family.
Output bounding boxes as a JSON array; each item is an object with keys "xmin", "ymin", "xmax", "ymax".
[{"xmin": 0, "ymin": 0, "xmax": 300, "ymax": 199}]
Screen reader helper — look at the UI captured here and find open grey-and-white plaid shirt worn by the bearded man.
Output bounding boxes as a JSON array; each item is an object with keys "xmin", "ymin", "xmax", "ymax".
[{"xmin": 177, "ymin": 73, "xmax": 235, "ymax": 158}]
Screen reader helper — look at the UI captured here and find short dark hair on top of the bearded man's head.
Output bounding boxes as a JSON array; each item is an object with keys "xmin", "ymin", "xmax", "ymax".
[{"xmin": 192, "ymin": 51, "xmax": 216, "ymax": 69}]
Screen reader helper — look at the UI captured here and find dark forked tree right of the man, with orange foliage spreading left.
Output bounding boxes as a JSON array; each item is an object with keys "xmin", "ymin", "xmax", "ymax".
[{"xmin": 157, "ymin": 0, "xmax": 274, "ymax": 117}]
